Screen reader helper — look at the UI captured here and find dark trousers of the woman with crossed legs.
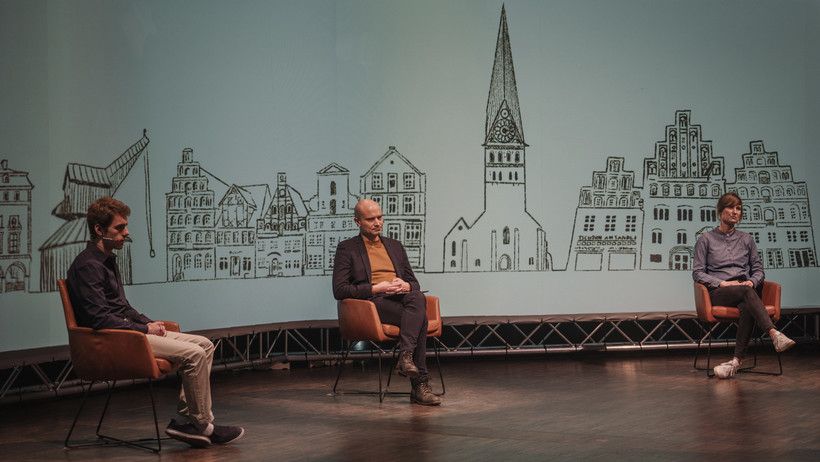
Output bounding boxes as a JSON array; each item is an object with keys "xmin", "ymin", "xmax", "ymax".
[{"xmin": 709, "ymin": 286, "xmax": 774, "ymax": 359}]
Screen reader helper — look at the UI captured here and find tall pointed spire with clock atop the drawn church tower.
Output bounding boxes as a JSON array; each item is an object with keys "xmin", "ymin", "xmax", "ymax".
[{"xmin": 484, "ymin": 6, "xmax": 524, "ymax": 145}]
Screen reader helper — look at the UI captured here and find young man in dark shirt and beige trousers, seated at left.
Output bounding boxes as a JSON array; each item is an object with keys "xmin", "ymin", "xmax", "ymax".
[{"xmin": 67, "ymin": 197, "xmax": 245, "ymax": 447}]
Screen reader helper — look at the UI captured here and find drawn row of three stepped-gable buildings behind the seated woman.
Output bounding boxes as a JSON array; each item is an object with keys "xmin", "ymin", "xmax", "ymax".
[{"xmin": 567, "ymin": 110, "xmax": 817, "ymax": 271}]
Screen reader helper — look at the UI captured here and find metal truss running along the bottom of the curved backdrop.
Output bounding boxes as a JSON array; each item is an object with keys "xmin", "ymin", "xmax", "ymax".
[{"xmin": 0, "ymin": 308, "xmax": 820, "ymax": 404}]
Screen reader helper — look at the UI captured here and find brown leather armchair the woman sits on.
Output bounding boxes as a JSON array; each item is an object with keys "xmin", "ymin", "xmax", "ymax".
[{"xmin": 694, "ymin": 281, "xmax": 783, "ymax": 377}]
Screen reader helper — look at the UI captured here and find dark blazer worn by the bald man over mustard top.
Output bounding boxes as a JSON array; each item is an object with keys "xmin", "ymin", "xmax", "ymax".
[{"xmin": 333, "ymin": 235, "xmax": 420, "ymax": 300}]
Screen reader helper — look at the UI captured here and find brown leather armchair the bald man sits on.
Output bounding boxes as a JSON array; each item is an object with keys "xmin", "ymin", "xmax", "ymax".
[{"xmin": 333, "ymin": 295, "xmax": 445, "ymax": 402}]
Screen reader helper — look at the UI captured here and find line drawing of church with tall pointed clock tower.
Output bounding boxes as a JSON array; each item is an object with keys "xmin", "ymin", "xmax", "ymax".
[{"xmin": 443, "ymin": 6, "xmax": 552, "ymax": 272}]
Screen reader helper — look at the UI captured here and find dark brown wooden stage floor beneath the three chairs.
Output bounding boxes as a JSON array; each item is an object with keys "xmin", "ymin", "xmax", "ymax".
[{"xmin": 0, "ymin": 345, "xmax": 820, "ymax": 462}]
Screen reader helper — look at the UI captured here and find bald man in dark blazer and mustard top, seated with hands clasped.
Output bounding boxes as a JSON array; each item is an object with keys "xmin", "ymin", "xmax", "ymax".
[{"xmin": 333, "ymin": 199, "xmax": 441, "ymax": 406}]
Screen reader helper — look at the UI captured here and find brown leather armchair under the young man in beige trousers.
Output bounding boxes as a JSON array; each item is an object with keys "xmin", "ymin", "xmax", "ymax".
[{"xmin": 57, "ymin": 279, "xmax": 179, "ymax": 452}]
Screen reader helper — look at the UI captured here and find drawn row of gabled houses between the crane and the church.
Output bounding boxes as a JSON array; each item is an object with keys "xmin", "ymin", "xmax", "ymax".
[{"xmin": 166, "ymin": 146, "xmax": 426, "ymax": 282}]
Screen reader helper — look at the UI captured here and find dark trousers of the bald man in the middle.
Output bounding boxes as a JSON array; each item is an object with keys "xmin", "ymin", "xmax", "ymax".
[{"xmin": 370, "ymin": 290, "xmax": 427, "ymax": 385}]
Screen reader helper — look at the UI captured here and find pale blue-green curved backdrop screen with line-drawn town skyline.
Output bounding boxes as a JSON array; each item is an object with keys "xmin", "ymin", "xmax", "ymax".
[{"xmin": 0, "ymin": 1, "xmax": 820, "ymax": 350}]
